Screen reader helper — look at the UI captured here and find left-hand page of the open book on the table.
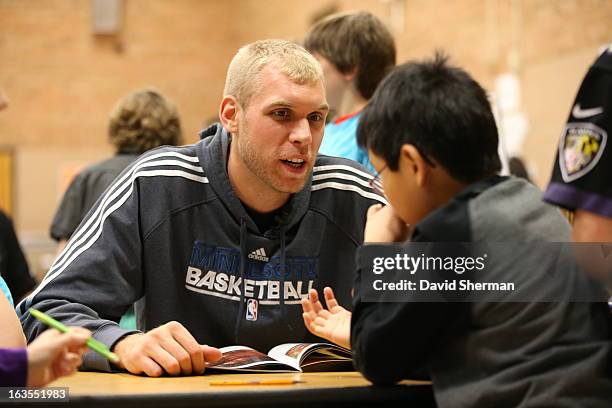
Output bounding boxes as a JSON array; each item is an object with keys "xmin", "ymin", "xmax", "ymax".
[{"xmin": 206, "ymin": 346, "xmax": 295, "ymax": 372}]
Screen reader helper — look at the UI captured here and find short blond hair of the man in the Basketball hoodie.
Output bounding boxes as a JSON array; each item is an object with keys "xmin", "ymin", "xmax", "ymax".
[{"xmin": 223, "ymin": 40, "xmax": 323, "ymax": 107}]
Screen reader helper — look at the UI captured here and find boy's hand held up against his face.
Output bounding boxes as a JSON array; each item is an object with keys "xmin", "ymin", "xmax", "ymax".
[{"xmin": 364, "ymin": 204, "xmax": 409, "ymax": 242}]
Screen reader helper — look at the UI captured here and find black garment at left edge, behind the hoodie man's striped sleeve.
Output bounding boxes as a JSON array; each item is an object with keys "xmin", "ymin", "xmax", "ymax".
[{"xmin": 0, "ymin": 212, "xmax": 36, "ymax": 302}]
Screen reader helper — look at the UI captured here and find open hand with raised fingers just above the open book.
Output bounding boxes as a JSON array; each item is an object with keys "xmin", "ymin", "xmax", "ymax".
[{"xmin": 302, "ymin": 287, "xmax": 351, "ymax": 349}]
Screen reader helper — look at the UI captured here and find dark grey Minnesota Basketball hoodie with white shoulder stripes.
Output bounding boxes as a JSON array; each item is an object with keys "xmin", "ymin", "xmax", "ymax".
[{"xmin": 18, "ymin": 126, "xmax": 384, "ymax": 370}]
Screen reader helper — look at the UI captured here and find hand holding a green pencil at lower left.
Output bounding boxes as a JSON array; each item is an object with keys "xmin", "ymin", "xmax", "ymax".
[{"xmin": 27, "ymin": 327, "xmax": 91, "ymax": 387}]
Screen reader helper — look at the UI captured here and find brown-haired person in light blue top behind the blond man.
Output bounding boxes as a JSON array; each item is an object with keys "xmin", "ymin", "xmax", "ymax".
[{"xmin": 304, "ymin": 11, "xmax": 396, "ymax": 170}]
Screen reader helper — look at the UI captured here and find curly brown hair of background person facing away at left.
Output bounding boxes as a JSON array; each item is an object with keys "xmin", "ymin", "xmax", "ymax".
[{"xmin": 108, "ymin": 88, "xmax": 181, "ymax": 154}]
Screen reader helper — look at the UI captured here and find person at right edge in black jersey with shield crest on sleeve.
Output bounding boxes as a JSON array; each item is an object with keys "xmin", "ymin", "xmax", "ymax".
[{"xmin": 544, "ymin": 44, "xmax": 612, "ymax": 247}]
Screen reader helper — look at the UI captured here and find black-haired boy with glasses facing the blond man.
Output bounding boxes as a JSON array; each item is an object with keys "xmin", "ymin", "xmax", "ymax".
[{"xmin": 303, "ymin": 55, "xmax": 612, "ymax": 407}]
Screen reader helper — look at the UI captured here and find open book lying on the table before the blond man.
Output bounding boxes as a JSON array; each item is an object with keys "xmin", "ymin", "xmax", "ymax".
[{"xmin": 207, "ymin": 343, "xmax": 354, "ymax": 373}]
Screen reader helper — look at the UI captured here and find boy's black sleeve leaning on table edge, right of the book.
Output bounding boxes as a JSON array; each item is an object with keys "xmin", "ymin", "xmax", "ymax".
[{"xmin": 351, "ymin": 271, "xmax": 468, "ymax": 384}]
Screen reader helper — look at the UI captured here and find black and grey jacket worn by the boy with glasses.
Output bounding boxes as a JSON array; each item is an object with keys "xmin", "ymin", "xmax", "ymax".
[{"xmin": 351, "ymin": 178, "xmax": 612, "ymax": 408}]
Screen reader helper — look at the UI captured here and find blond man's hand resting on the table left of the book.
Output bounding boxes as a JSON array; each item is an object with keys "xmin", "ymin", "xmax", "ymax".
[{"xmin": 113, "ymin": 322, "xmax": 221, "ymax": 377}]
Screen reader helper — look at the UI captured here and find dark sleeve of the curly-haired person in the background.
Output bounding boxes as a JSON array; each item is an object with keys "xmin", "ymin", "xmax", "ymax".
[{"xmin": 49, "ymin": 175, "xmax": 86, "ymax": 241}]
